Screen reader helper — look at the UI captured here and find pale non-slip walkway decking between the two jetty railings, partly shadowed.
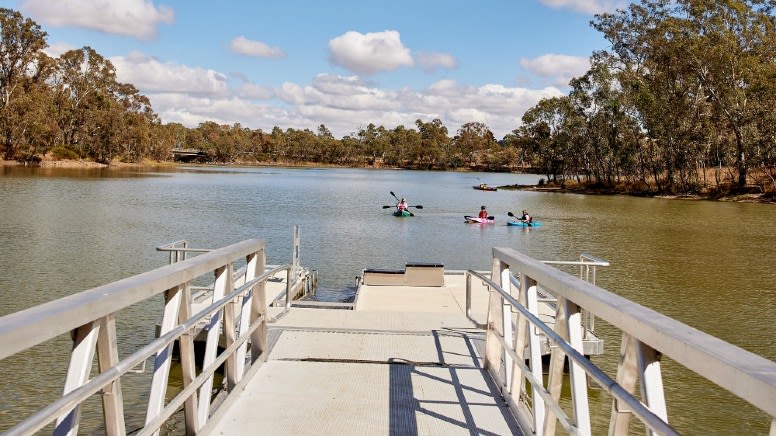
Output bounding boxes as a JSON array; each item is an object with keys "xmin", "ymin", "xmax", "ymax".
[{"xmin": 204, "ymin": 275, "xmax": 519, "ymax": 435}]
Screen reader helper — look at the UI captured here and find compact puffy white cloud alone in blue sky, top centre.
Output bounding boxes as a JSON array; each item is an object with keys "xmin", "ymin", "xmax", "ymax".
[{"xmin": 329, "ymin": 30, "xmax": 413, "ymax": 75}]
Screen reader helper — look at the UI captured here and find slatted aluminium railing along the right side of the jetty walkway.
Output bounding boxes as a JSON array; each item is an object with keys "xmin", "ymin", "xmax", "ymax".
[{"xmin": 467, "ymin": 248, "xmax": 776, "ymax": 435}]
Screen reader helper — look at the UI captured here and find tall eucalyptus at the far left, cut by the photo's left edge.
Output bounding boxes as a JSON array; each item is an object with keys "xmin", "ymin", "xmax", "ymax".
[{"xmin": 0, "ymin": 8, "xmax": 48, "ymax": 159}]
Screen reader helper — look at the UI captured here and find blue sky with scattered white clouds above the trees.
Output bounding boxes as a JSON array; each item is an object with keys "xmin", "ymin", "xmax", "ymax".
[{"xmin": 0, "ymin": 0, "xmax": 626, "ymax": 139}]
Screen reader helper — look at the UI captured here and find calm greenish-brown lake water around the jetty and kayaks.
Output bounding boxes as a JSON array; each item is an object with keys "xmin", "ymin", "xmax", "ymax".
[{"xmin": 0, "ymin": 168, "xmax": 776, "ymax": 434}]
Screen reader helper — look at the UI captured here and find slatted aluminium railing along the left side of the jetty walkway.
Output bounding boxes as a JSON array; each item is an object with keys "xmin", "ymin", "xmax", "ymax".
[{"xmin": 0, "ymin": 240, "xmax": 278, "ymax": 435}]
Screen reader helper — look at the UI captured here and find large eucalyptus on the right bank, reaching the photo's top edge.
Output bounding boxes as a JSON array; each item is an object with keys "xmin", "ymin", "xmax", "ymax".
[{"xmin": 593, "ymin": 0, "xmax": 776, "ymax": 191}]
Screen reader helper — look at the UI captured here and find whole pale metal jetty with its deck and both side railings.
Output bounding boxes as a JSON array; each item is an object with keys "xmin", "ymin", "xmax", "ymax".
[{"xmin": 0, "ymin": 229, "xmax": 776, "ymax": 435}]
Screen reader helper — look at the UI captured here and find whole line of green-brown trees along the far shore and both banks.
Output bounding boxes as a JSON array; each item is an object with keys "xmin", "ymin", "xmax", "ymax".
[{"xmin": 0, "ymin": 0, "xmax": 776, "ymax": 193}]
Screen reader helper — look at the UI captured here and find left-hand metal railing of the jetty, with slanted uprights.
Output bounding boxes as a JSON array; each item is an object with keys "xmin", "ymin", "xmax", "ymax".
[{"xmin": 0, "ymin": 240, "xmax": 291, "ymax": 435}]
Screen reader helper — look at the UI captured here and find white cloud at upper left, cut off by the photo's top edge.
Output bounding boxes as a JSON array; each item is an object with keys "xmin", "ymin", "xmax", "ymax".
[{"xmin": 19, "ymin": 0, "xmax": 174, "ymax": 39}]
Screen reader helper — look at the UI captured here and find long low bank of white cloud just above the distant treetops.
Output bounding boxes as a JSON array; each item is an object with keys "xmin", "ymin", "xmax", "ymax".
[{"xmin": 106, "ymin": 53, "xmax": 563, "ymax": 138}]
